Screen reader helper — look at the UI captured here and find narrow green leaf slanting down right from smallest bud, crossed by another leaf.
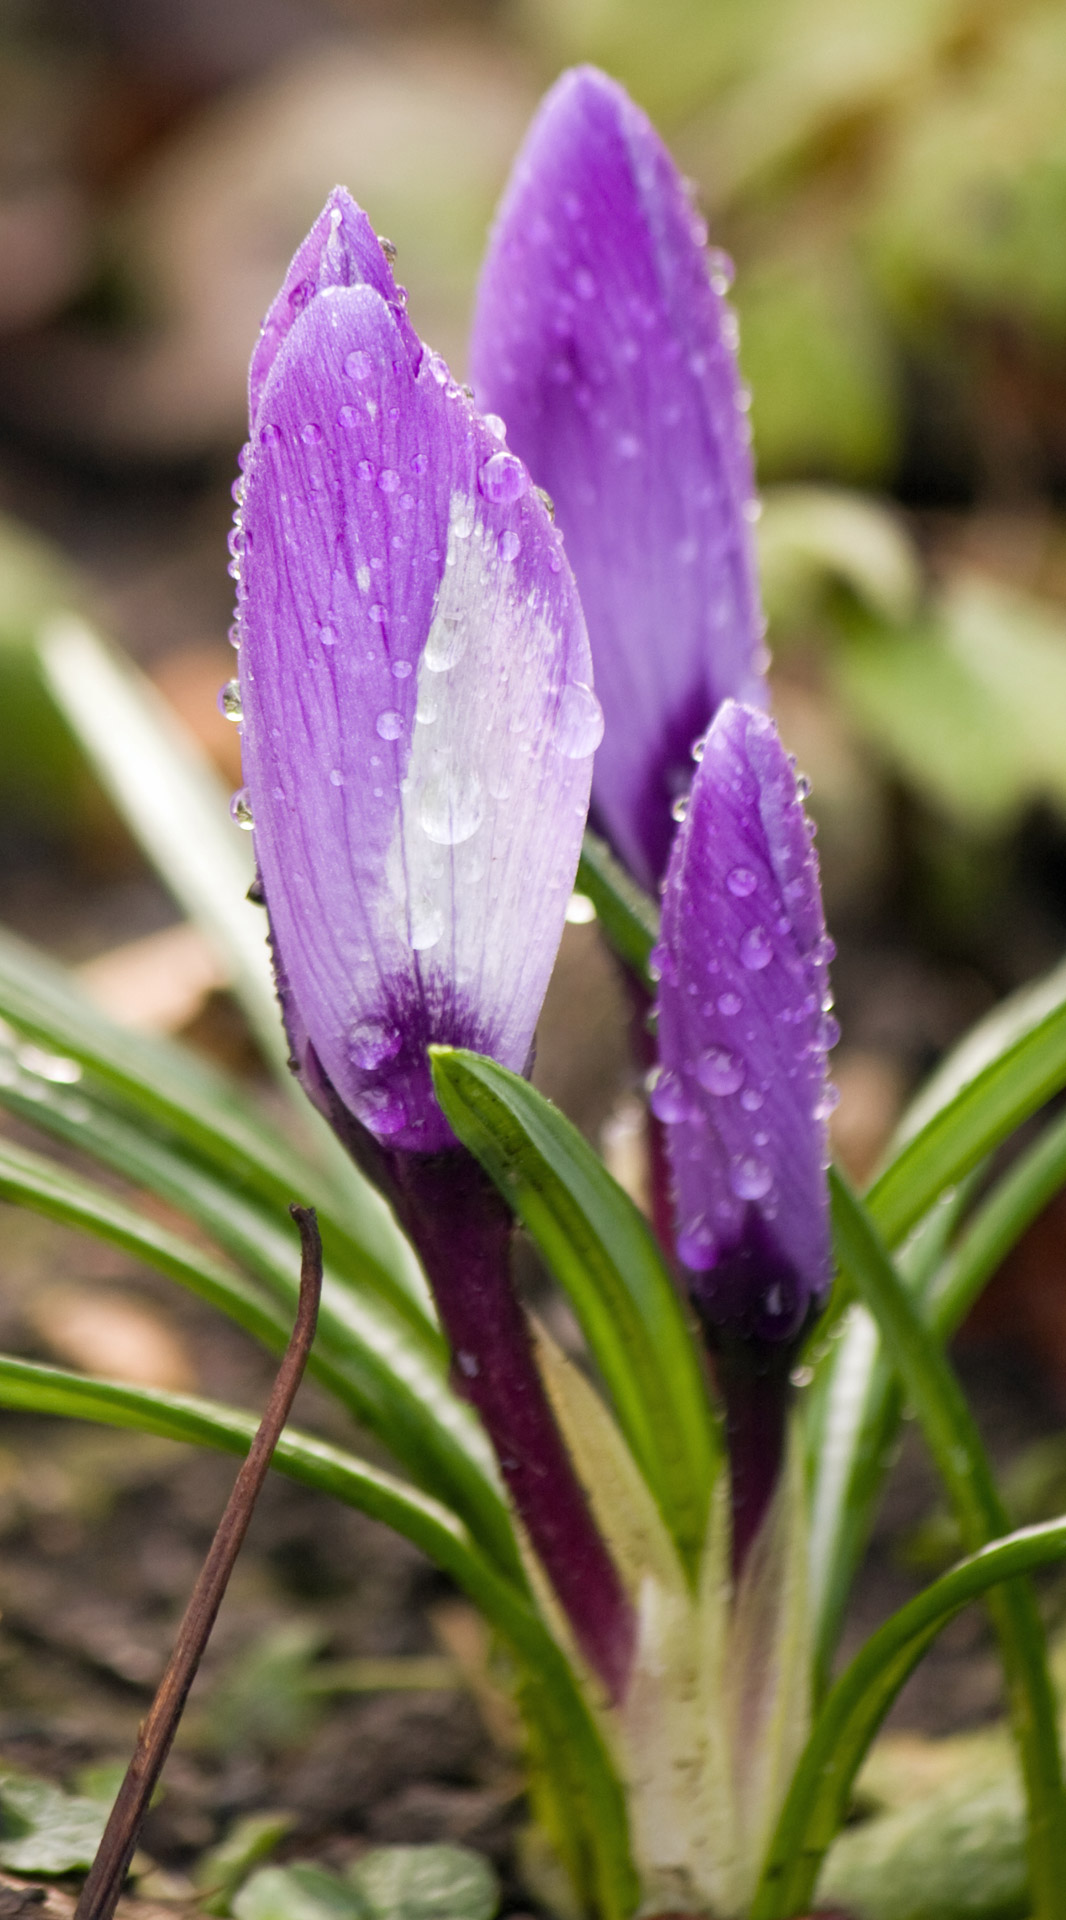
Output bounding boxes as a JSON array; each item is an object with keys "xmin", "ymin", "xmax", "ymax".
[{"xmin": 830, "ymin": 1175, "xmax": 1066, "ymax": 1920}]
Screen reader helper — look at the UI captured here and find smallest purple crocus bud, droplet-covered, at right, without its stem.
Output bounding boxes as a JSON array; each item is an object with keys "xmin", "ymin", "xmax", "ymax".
[{"xmin": 651, "ymin": 701, "xmax": 836, "ymax": 1342}]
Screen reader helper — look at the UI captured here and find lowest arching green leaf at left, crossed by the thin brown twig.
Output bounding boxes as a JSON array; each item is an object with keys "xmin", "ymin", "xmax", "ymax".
[{"xmin": 0, "ymin": 1356, "xmax": 638, "ymax": 1920}]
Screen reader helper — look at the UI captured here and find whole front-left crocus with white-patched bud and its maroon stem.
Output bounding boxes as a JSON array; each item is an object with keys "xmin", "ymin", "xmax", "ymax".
[{"xmin": 232, "ymin": 190, "xmax": 634, "ymax": 1697}]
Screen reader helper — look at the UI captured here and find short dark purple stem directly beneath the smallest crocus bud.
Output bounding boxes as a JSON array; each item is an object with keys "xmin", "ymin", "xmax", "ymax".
[{"xmin": 709, "ymin": 1329, "xmax": 793, "ymax": 1580}]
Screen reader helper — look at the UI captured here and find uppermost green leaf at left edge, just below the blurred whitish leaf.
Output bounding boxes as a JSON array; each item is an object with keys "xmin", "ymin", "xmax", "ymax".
[{"xmin": 0, "ymin": 933, "xmax": 426, "ymax": 1319}]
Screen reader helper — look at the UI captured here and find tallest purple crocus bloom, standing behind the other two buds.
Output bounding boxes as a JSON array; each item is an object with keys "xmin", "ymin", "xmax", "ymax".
[{"xmin": 471, "ymin": 67, "xmax": 766, "ymax": 889}]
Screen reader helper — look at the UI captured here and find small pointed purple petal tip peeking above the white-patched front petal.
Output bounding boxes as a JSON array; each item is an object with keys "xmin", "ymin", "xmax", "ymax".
[{"xmin": 248, "ymin": 186, "xmax": 421, "ymax": 426}]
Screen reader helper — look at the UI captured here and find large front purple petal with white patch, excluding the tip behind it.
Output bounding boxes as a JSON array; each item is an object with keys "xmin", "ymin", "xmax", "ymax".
[{"xmin": 236, "ymin": 272, "xmax": 603, "ymax": 1152}]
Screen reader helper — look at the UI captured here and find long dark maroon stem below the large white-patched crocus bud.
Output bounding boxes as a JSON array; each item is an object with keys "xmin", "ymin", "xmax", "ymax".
[{"xmin": 388, "ymin": 1148, "xmax": 636, "ymax": 1701}]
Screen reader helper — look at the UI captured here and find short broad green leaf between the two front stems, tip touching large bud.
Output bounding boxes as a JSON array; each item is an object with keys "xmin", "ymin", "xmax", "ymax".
[{"xmin": 430, "ymin": 1046, "xmax": 722, "ymax": 1572}]
